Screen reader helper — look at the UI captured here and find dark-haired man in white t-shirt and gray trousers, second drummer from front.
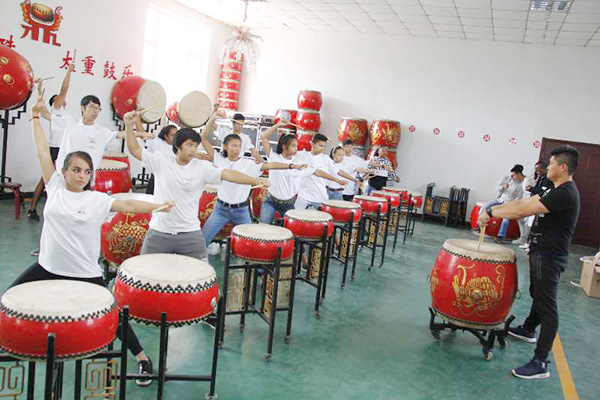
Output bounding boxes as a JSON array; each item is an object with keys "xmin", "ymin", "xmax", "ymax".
[{"xmin": 124, "ymin": 111, "xmax": 269, "ymax": 262}]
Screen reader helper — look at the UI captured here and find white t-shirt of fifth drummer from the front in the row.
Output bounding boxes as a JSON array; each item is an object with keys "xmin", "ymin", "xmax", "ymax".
[{"xmin": 295, "ymin": 150, "xmax": 339, "ymax": 203}]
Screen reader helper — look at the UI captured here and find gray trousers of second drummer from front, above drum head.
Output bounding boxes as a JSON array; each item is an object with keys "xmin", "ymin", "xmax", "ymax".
[{"xmin": 142, "ymin": 229, "xmax": 208, "ymax": 262}]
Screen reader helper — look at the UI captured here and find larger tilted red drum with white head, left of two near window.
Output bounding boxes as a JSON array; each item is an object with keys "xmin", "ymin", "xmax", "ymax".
[{"xmin": 110, "ymin": 75, "xmax": 167, "ymax": 124}]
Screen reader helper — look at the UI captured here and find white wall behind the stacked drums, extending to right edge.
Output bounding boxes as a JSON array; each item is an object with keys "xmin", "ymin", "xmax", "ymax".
[{"xmin": 240, "ymin": 31, "xmax": 600, "ymax": 212}]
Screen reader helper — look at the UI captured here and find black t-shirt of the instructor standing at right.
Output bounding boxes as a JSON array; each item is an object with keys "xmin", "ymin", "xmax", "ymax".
[{"xmin": 531, "ymin": 181, "xmax": 579, "ymax": 254}]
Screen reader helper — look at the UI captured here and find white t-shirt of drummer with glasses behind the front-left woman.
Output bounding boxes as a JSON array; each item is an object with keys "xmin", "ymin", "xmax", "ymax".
[{"xmin": 51, "ymin": 114, "xmax": 117, "ymax": 178}]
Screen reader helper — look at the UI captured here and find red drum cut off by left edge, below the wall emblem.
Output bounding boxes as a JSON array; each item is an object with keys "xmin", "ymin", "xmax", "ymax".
[{"xmin": 0, "ymin": 45, "xmax": 33, "ymax": 110}]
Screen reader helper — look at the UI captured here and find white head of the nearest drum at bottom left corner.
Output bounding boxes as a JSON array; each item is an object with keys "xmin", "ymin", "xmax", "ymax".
[{"xmin": 0, "ymin": 280, "xmax": 115, "ymax": 322}]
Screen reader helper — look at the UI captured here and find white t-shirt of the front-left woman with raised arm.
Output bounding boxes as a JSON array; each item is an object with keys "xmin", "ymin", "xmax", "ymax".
[{"xmin": 39, "ymin": 172, "xmax": 114, "ymax": 278}]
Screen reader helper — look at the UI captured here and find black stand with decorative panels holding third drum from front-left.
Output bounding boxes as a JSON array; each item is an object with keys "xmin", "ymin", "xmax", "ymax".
[{"xmin": 219, "ymin": 238, "xmax": 298, "ymax": 361}]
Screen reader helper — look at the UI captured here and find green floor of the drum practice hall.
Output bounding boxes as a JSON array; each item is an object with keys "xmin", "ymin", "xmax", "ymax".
[{"xmin": 0, "ymin": 200, "xmax": 600, "ymax": 400}]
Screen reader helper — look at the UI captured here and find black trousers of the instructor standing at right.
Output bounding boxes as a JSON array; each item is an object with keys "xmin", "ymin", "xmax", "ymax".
[{"xmin": 523, "ymin": 251, "xmax": 568, "ymax": 361}]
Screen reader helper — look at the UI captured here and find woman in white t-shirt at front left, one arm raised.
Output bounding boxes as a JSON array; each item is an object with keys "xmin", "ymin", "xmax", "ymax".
[{"xmin": 11, "ymin": 96, "xmax": 172, "ymax": 386}]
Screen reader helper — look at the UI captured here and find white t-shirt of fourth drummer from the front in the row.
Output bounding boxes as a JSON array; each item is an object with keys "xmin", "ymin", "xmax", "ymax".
[{"xmin": 267, "ymin": 150, "xmax": 315, "ymax": 200}]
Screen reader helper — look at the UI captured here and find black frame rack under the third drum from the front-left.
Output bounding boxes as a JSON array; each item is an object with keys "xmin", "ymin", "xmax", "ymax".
[{"xmin": 219, "ymin": 237, "xmax": 298, "ymax": 362}]
